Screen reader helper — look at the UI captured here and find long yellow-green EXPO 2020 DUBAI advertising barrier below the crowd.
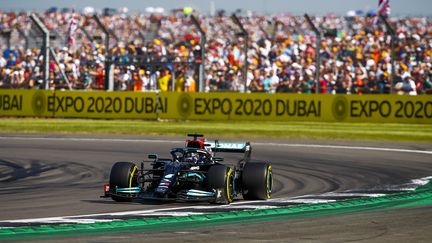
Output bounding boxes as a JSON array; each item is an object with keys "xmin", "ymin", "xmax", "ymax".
[{"xmin": 0, "ymin": 90, "xmax": 432, "ymax": 123}]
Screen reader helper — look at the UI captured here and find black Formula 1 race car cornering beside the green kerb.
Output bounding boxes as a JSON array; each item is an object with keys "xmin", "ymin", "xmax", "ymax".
[{"xmin": 102, "ymin": 134, "xmax": 273, "ymax": 204}]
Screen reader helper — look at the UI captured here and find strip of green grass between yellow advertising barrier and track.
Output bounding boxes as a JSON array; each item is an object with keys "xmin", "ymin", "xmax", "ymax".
[{"xmin": 0, "ymin": 118, "xmax": 432, "ymax": 142}]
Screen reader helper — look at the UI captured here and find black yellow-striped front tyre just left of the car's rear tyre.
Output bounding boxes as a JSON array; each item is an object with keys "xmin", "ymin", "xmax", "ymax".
[{"xmin": 207, "ymin": 165, "xmax": 235, "ymax": 204}]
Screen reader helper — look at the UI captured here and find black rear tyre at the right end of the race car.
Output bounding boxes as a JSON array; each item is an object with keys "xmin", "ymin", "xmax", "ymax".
[{"xmin": 242, "ymin": 162, "xmax": 273, "ymax": 200}]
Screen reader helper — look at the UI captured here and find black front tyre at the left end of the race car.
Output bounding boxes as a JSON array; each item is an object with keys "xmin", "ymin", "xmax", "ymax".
[{"xmin": 109, "ymin": 162, "xmax": 137, "ymax": 202}]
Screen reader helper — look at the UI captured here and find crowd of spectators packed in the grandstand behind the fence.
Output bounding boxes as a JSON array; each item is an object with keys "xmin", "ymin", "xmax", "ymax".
[{"xmin": 0, "ymin": 8, "xmax": 432, "ymax": 95}]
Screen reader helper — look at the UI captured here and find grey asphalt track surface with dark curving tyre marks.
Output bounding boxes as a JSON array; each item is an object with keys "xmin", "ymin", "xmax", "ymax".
[{"xmin": 0, "ymin": 134, "xmax": 432, "ymax": 242}]
